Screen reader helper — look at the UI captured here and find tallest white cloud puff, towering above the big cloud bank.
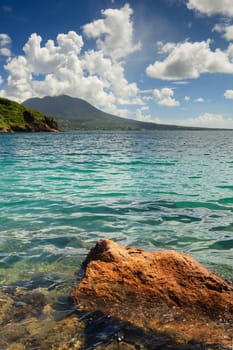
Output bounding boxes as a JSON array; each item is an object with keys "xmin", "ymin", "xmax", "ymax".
[{"xmin": 83, "ymin": 4, "xmax": 140, "ymax": 60}]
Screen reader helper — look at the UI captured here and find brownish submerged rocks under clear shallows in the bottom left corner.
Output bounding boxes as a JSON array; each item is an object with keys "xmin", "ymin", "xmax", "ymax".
[{"xmin": 0, "ymin": 275, "xmax": 84, "ymax": 350}]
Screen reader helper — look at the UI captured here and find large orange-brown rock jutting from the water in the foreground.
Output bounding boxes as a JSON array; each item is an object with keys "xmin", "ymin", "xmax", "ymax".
[{"xmin": 71, "ymin": 239, "xmax": 233, "ymax": 348}]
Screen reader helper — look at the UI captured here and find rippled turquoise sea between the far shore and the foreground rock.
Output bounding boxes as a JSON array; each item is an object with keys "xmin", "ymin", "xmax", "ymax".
[{"xmin": 0, "ymin": 131, "xmax": 233, "ymax": 284}]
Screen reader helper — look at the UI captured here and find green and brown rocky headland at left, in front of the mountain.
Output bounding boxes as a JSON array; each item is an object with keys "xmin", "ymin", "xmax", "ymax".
[{"xmin": 0, "ymin": 98, "xmax": 58, "ymax": 132}]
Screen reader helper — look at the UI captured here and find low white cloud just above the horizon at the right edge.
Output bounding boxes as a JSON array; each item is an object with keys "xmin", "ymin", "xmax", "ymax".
[{"xmin": 176, "ymin": 113, "xmax": 233, "ymax": 129}]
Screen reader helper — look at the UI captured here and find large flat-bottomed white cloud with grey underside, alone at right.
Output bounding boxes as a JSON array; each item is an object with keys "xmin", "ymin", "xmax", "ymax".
[{"xmin": 146, "ymin": 40, "xmax": 233, "ymax": 80}]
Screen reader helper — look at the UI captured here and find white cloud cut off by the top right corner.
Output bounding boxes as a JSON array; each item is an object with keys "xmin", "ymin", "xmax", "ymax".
[{"xmin": 187, "ymin": 0, "xmax": 233, "ymax": 17}]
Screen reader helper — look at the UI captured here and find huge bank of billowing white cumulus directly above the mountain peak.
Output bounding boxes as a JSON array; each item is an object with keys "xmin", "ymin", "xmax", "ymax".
[{"xmin": 0, "ymin": 5, "xmax": 144, "ymax": 117}]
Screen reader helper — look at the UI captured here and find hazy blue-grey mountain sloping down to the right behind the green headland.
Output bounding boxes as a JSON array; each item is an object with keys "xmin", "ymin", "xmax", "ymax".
[{"xmin": 23, "ymin": 95, "xmax": 187, "ymax": 130}]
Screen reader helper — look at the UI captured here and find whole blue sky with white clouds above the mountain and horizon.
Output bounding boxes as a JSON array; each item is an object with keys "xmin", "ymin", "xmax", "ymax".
[{"xmin": 0, "ymin": 0, "xmax": 233, "ymax": 129}]
